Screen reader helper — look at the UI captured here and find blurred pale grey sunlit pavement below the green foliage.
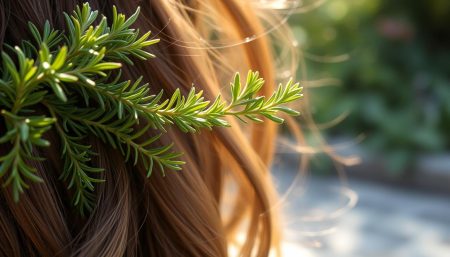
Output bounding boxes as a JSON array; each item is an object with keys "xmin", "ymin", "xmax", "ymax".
[{"xmin": 275, "ymin": 164, "xmax": 450, "ymax": 257}]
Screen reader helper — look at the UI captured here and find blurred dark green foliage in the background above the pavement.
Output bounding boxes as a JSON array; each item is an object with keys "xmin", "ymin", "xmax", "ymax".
[{"xmin": 290, "ymin": 0, "xmax": 450, "ymax": 175}]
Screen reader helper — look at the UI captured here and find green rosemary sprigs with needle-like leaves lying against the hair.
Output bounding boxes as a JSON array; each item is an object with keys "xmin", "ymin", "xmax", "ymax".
[{"xmin": 0, "ymin": 3, "xmax": 302, "ymax": 213}]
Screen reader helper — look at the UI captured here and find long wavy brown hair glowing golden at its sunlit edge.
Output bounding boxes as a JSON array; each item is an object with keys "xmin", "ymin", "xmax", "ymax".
[{"xmin": 0, "ymin": 0, "xmax": 286, "ymax": 257}]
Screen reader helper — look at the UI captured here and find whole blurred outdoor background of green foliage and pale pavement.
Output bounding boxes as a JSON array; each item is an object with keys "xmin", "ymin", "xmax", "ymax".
[{"xmin": 275, "ymin": 0, "xmax": 450, "ymax": 257}]
